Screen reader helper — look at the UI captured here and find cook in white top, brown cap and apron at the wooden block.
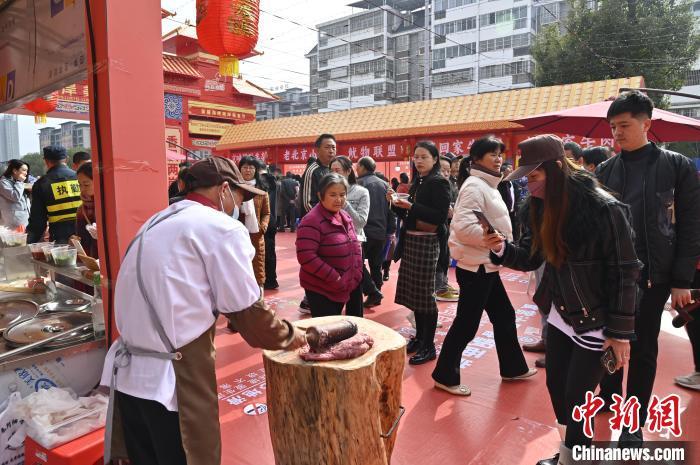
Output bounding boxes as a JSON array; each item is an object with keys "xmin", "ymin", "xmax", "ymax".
[{"xmin": 102, "ymin": 157, "xmax": 304, "ymax": 465}]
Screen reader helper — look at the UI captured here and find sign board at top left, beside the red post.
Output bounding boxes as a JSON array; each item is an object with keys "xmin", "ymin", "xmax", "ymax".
[{"xmin": 0, "ymin": 0, "xmax": 87, "ymax": 112}]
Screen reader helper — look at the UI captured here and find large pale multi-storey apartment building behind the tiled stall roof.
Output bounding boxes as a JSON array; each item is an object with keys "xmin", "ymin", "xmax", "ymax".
[{"xmin": 306, "ymin": 0, "xmax": 567, "ymax": 112}]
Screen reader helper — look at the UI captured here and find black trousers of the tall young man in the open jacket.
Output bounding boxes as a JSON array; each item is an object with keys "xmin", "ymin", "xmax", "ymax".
[{"xmin": 600, "ymin": 284, "xmax": 671, "ymax": 425}]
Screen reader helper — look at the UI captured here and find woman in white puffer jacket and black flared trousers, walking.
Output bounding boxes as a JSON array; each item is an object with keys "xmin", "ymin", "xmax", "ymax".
[{"xmin": 433, "ymin": 136, "xmax": 537, "ymax": 395}]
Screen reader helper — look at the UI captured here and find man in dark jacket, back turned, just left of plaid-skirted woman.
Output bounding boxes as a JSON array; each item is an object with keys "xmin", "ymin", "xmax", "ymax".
[{"xmin": 356, "ymin": 157, "xmax": 389, "ymax": 308}]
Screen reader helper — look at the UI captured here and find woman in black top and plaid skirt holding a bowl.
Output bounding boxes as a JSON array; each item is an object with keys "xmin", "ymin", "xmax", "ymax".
[{"xmin": 387, "ymin": 141, "xmax": 450, "ymax": 365}]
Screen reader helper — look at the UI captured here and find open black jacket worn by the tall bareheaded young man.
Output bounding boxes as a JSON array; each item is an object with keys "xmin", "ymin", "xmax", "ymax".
[{"xmin": 596, "ymin": 145, "xmax": 700, "ymax": 289}]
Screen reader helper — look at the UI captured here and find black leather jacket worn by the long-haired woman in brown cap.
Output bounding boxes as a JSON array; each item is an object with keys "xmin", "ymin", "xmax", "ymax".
[{"xmin": 491, "ymin": 174, "xmax": 641, "ymax": 339}]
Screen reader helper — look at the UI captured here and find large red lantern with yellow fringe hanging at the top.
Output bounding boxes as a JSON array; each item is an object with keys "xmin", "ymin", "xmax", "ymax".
[{"xmin": 197, "ymin": 0, "xmax": 260, "ymax": 76}]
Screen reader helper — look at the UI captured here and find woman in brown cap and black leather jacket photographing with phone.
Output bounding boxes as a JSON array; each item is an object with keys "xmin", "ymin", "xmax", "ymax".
[{"xmin": 484, "ymin": 135, "xmax": 640, "ymax": 465}]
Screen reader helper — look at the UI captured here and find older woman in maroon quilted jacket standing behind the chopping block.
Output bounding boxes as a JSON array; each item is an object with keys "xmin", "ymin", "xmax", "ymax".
[{"xmin": 296, "ymin": 173, "xmax": 362, "ymax": 317}]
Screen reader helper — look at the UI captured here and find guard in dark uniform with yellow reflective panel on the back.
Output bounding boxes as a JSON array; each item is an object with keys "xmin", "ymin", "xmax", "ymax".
[{"xmin": 27, "ymin": 146, "xmax": 81, "ymax": 244}]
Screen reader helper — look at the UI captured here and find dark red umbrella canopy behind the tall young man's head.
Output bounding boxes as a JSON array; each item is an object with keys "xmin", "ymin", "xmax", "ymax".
[{"xmin": 511, "ymin": 101, "xmax": 700, "ymax": 142}]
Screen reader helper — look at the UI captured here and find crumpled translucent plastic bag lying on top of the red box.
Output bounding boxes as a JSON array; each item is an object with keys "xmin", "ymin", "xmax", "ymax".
[{"xmin": 22, "ymin": 388, "xmax": 109, "ymax": 449}]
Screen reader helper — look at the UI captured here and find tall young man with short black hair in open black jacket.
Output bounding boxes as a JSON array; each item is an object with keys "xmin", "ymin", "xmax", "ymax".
[{"xmin": 596, "ymin": 91, "xmax": 700, "ymax": 445}]
